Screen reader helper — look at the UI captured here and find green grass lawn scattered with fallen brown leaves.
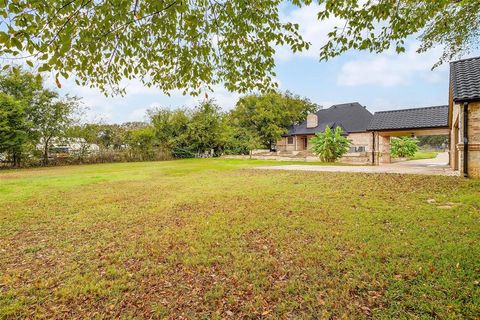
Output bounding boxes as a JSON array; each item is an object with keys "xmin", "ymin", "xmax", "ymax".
[{"xmin": 0, "ymin": 159, "xmax": 480, "ymax": 319}]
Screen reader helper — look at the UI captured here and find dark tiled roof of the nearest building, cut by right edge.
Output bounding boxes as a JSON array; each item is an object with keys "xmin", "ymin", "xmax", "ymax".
[{"xmin": 450, "ymin": 57, "xmax": 480, "ymax": 102}]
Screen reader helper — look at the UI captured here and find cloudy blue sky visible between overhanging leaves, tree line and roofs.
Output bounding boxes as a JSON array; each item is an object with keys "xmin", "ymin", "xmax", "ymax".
[{"xmin": 55, "ymin": 6, "xmax": 458, "ymax": 123}]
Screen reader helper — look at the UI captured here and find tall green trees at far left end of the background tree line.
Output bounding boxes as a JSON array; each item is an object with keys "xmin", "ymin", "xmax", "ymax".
[{"xmin": 0, "ymin": 68, "xmax": 79, "ymax": 166}]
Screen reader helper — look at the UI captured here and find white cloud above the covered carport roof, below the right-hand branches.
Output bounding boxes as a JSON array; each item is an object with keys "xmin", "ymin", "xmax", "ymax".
[{"xmin": 337, "ymin": 42, "xmax": 446, "ymax": 87}]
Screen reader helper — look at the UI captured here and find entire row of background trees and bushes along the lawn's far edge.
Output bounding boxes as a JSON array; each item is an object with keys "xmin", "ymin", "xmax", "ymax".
[{"xmin": 0, "ymin": 68, "xmax": 318, "ymax": 167}]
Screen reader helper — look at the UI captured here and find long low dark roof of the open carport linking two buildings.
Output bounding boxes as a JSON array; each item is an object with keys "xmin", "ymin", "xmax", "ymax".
[{"xmin": 368, "ymin": 106, "xmax": 448, "ymax": 131}]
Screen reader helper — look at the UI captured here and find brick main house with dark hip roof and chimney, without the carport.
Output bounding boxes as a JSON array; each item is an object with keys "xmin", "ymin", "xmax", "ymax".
[{"xmin": 277, "ymin": 102, "xmax": 373, "ymax": 163}]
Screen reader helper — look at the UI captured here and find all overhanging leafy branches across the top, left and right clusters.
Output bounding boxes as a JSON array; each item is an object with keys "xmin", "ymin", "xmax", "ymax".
[{"xmin": 0, "ymin": 0, "xmax": 480, "ymax": 94}]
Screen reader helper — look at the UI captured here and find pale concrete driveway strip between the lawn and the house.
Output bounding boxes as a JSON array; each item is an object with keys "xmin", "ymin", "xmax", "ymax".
[{"xmin": 254, "ymin": 152, "xmax": 458, "ymax": 176}]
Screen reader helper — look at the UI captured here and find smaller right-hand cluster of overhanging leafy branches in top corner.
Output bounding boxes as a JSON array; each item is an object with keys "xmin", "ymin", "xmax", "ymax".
[{"xmin": 318, "ymin": 0, "xmax": 480, "ymax": 65}]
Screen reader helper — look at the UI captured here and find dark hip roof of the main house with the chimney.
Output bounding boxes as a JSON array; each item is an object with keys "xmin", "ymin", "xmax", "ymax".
[{"xmin": 286, "ymin": 102, "xmax": 373, "ymax": 135}]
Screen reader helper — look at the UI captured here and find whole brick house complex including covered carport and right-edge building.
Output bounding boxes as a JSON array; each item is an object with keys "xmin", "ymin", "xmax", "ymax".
[{"xmin": 277, "ymin": 57, "xmax": 480, "ymax": 178}]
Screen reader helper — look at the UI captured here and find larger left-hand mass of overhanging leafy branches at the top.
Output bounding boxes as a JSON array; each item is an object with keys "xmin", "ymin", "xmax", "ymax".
[{"xmin": 0, "ymin": 0, "xmax": 308, "ymax": 93}]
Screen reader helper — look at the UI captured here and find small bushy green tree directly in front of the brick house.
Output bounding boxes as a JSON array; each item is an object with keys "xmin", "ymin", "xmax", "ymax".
[{"xmin": 311, "ymin": 127, "xmax": 350, "ymax": 162}]
